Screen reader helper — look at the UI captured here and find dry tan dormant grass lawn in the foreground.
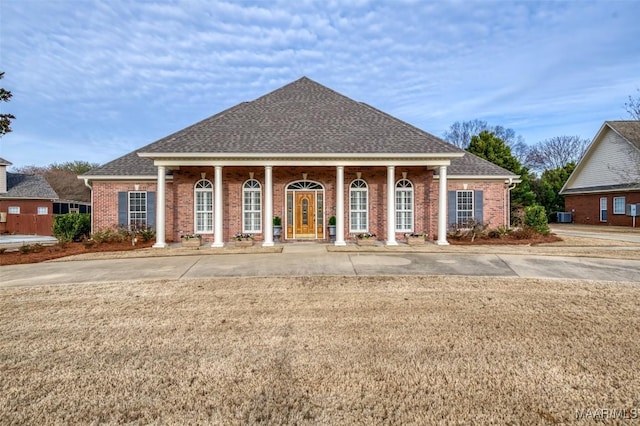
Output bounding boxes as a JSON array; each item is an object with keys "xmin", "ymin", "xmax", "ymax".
[{"xmin": 0, "ymin": 277, "xmax": 640, "ymax": 424}]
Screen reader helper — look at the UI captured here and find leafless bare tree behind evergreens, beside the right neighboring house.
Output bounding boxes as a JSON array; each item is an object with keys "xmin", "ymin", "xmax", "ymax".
[{"xmin": 526, "ymin": 136, "xmax": 591, "ymax": 171}]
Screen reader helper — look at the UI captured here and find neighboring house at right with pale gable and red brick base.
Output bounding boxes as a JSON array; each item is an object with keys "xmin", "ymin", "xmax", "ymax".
[{"xmin": 560, "ymin": 120, "xmax": 640, "ymax": 226}]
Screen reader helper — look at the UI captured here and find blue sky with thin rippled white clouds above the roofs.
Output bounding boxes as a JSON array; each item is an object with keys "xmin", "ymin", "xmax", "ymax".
[{"xmin": 0, "ymin": 0, "xmax": 640, "ymax": 167}]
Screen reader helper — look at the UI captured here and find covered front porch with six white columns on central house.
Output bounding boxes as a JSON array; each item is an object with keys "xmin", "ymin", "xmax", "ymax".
[{"xmin": 139, "ymin": 154, "xmax": 455, "ymax": 248}]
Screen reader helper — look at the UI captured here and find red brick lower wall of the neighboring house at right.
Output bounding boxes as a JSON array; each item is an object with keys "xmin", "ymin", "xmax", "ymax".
[{"xmin": 564, "ymin": 192, "xmax": 640, "ymax": 226}]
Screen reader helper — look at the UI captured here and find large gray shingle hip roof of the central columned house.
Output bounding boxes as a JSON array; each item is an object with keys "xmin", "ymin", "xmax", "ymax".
[{"xmin": 86, "ymin": 77, "xmax": 509, "ymax": 176}]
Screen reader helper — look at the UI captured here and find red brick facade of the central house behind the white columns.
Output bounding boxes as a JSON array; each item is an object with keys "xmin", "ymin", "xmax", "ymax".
[{"xmin": 93, "ymin": 166, "xmax": 508, "ymax": 242}]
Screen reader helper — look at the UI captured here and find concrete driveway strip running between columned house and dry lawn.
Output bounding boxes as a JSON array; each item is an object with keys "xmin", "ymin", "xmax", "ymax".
[{"xmin": 0, "ymin": 244, "xmax": 640, "ymax": 287}]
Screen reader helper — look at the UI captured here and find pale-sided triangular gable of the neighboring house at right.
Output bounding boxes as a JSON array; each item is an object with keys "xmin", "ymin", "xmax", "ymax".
[{"xmin": 560, "ymin": 121, "xmax": 640, "ymax": 194}]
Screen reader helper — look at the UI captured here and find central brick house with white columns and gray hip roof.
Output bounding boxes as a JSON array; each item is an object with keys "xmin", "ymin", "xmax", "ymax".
[{"xmin": 80, "ymin": 77, "xmax": 519, "ymax": 247}]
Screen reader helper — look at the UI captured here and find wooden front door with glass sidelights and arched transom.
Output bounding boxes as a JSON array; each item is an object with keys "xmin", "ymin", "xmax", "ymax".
[{"xmin": 286, "ymin": 181, "xmax": 324, "ymax": 240}]
